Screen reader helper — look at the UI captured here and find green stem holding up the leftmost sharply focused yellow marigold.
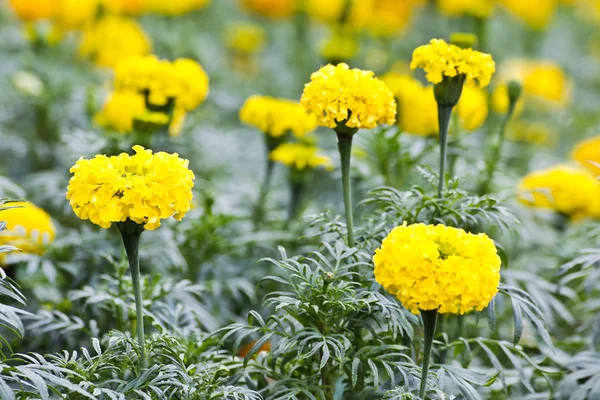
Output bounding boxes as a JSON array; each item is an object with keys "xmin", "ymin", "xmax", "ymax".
[{"xmin": 121, "ymin": 227, "xmax": 146, "ymax": 369}]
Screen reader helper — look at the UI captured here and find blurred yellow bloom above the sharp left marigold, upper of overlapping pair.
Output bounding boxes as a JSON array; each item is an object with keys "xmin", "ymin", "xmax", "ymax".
[{"xmin": 115, "ymin": 55, "xmax": 208, "ymax": 111}]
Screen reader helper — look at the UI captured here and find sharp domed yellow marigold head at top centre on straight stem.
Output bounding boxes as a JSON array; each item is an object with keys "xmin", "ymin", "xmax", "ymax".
[{"xmin": 301, "ymin": 63, "xmax": 396, "ymax": 129}]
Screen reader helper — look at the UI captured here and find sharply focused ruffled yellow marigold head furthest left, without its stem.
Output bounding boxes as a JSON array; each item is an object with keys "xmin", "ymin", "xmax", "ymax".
[{"xmin": 67, "ymin": 146, "xmax": 194, "ymax": 230}]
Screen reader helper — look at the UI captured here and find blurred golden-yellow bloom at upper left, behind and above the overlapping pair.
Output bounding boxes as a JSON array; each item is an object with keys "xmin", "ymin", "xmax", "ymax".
[{"xmin": 79, "ymin": 15, "xmax": 151, "ymax": 68}]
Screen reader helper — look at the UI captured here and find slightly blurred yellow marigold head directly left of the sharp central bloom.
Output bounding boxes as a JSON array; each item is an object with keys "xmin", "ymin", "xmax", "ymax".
[{"xmin": 240, "ymin": 95, "xmax": 317, "ymax": 138}]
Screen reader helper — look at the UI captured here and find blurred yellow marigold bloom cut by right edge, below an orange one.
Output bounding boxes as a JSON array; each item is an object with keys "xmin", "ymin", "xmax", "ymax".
[{"xmin": 518, "ymin": 165, "xmax": 600, "ymax": 220}]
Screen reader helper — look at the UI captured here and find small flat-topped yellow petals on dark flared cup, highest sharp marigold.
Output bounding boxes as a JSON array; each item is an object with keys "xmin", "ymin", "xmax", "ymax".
[{"xmin": 410, "ymin": 39, "xmax": 496, "ymax": 87}]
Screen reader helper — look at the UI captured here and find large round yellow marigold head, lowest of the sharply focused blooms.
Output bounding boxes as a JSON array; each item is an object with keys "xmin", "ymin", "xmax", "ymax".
[{"xmin": 373, "ymin": 223, "xmax": 500, "ymax": 314}]
